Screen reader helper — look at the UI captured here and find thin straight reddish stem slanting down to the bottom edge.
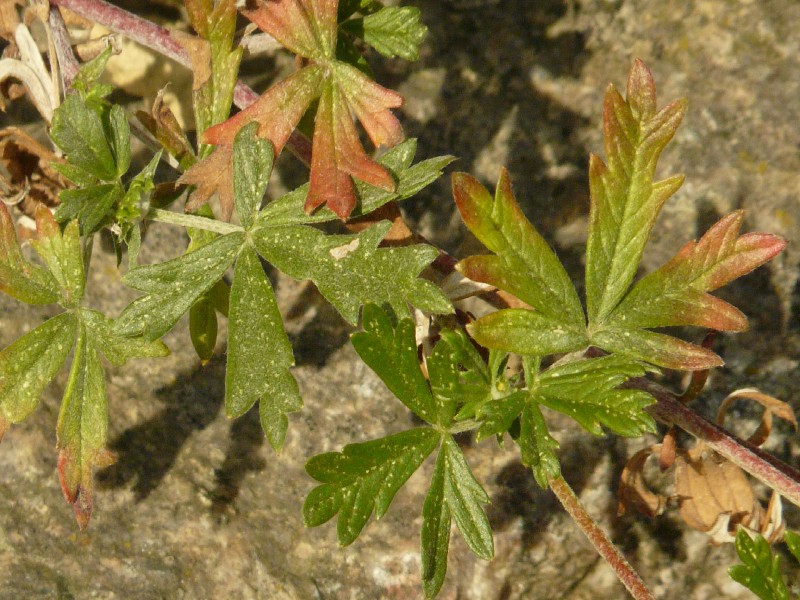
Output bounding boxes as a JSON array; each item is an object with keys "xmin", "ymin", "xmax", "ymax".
[{"xmin": 548, "ymin": 476, "xmax": 654, "ymax": 600}]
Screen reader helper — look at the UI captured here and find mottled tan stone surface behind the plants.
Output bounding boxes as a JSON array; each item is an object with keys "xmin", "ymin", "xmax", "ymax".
[{"xmin": 0, "ymin": 0, "xmax": 800, "ymax": 600}]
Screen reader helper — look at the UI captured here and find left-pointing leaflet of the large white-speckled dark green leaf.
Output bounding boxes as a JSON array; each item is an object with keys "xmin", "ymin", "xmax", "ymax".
[{"xmin": 115, "ymin": 232, "xmax": 244, "ymax": 340}]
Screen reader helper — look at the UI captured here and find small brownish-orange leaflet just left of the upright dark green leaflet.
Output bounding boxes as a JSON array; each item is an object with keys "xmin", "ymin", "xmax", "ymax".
[{"xmin": 178, "ymin": 146, "xmax": 234, "ymax": 221}]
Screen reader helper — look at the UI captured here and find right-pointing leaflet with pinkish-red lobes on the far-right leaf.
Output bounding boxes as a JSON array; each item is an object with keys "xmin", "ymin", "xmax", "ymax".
[{"xmin": 609, "ymin": 211, "xmax": 786, "ymax": 331}]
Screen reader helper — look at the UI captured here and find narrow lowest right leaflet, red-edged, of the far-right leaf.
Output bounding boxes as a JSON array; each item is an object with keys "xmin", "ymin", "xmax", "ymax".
[{"xmin": 592, "ymin": 327, "xmax": 724, "ymax": 371}]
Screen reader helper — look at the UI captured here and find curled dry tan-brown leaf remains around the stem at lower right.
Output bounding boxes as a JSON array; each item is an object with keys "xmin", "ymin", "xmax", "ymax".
[{"xmin": 618, "ymin": 388, "xmax": 797, "ymax": 544}]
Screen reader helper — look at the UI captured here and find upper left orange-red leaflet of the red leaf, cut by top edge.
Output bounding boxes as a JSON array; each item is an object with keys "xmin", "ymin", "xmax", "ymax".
[{"xmin": 242, "ymin": 0, "xmax": 339, "ymax": 58}]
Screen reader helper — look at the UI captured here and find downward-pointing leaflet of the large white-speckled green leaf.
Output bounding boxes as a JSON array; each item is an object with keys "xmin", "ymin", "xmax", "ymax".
[{"xmin": 225, "ymin": 246, "xmax": 302, "ymax": 450}]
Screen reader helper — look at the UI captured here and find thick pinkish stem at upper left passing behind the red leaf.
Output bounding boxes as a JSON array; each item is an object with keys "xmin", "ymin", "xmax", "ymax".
[{"xmin": 45, "ymin": 0, "xmax": 311, "ymax": 165}]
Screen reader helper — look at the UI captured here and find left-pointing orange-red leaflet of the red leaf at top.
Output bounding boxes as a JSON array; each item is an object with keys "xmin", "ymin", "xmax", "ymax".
[{"xmin": 202, "ymin": 64, "xmax": 325, "ymax": 151}]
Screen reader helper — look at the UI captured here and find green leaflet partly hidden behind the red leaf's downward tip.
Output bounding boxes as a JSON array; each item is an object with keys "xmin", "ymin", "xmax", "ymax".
[{"xmin": 261, "ymin": 138, "xmax": 455, "ymax": 225}]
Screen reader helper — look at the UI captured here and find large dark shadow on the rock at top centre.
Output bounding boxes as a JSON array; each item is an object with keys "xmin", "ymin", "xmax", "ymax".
[{"xmin": 390, "ymin": 0, "xmax": 589, "ymax": 258}]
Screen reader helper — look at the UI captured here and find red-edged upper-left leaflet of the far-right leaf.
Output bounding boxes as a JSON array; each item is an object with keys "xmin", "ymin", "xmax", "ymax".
[{"xmin": 452, "ymin": 169, "xmax": 585, "ymax": 330}]
